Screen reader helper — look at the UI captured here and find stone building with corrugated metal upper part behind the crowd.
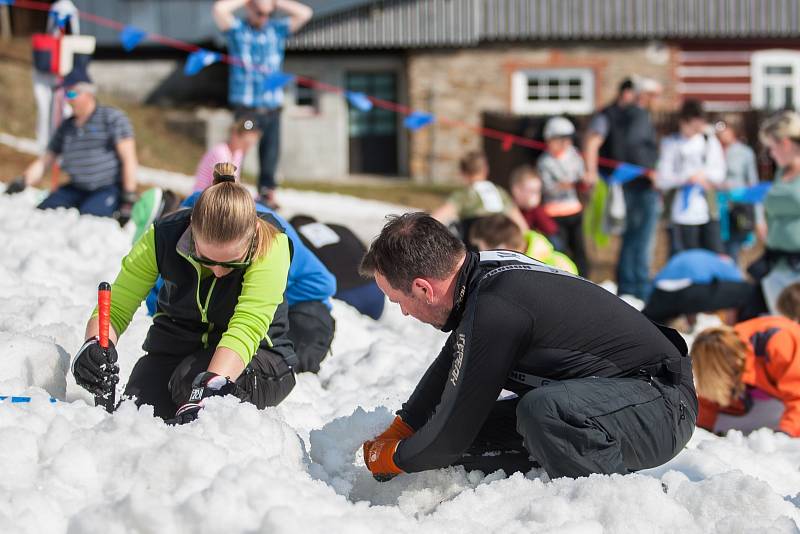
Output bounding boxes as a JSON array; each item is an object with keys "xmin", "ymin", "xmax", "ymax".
[{"xmin": 29, "ymin": 0, "xmax": 800, "ymax": 182}]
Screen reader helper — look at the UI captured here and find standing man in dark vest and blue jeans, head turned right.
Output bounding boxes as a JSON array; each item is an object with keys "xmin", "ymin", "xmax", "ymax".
[{"xmin": 584, "ymin": 78, "xmax": 661, "ymax": 300}]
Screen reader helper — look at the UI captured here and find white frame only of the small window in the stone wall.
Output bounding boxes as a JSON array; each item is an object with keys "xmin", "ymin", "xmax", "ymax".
[{"xmin": 511, "ymin": 68, "xmax": 595, "ymax": 115}]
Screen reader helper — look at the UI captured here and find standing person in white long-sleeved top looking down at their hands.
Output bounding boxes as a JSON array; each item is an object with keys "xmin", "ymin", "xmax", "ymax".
[{"xmin": 656, "ymin": 100, "xmax": 725, "ymax": 255}]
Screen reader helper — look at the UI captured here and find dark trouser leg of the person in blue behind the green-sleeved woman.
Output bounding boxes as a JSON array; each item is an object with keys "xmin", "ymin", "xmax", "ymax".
[{"xmin": 289, "ymin": 300, "xmax": 336, "ymax": 373}]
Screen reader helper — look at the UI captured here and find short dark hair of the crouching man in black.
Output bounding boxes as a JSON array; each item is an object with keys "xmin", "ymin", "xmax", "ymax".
[{"xmin": 359, "ymin": 212, "xmax": 466, "ymax": 293}]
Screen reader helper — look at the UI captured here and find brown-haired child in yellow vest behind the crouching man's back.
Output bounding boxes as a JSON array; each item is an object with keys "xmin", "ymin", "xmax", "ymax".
[{"xmin": 469, "ymin": 214, "xmax": 578, "ymax": 274}]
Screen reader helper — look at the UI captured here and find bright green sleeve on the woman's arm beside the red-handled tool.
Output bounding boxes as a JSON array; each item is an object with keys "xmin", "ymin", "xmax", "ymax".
[{"xmin": 92, "ymin": 226, "xmax": 158, "ymax": 336}]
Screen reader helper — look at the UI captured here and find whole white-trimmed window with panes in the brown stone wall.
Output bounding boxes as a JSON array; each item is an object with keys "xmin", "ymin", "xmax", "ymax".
[{"xmin": 511, "ymin": 69, "xmax": 594, "ymax": 115}]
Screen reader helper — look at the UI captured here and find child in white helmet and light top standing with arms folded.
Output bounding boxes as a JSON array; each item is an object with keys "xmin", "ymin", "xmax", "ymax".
[{"xmin": 536, "ymin": 117, "xmax": 589, "ymax": 277}]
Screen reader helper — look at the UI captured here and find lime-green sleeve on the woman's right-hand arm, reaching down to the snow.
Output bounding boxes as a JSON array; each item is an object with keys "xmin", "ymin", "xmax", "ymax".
[{"xmin": 217, "ymin": 234, "xmax": 290, "ymax": 366}]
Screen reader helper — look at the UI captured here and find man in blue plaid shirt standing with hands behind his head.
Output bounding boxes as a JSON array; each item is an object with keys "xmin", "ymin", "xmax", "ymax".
[{"xmin": 213, "ymin": 0, "xmax": 313, "ymax": 208}]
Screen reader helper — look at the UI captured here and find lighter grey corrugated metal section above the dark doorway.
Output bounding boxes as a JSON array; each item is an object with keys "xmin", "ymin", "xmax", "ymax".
[{"xmin": 289, "ymin": 0, "xmax": 481, "ymax": 50}]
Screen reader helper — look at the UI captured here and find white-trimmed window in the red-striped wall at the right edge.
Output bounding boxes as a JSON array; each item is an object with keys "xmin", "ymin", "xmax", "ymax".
[{"xmin": 750, "ymin": 50, "xmax": 800, "ymax": 110}]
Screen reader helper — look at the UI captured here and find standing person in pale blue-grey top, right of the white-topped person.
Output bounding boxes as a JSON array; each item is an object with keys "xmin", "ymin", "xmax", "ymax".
[{"xmin": 715, "ymin": 121, "xmax": 764, "ymax": 260}]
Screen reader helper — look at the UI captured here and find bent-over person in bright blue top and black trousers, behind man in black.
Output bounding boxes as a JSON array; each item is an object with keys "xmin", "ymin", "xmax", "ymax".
[{"xmin": 642, "ymin": 249, "xmax": 753, "ymax": 323}]
